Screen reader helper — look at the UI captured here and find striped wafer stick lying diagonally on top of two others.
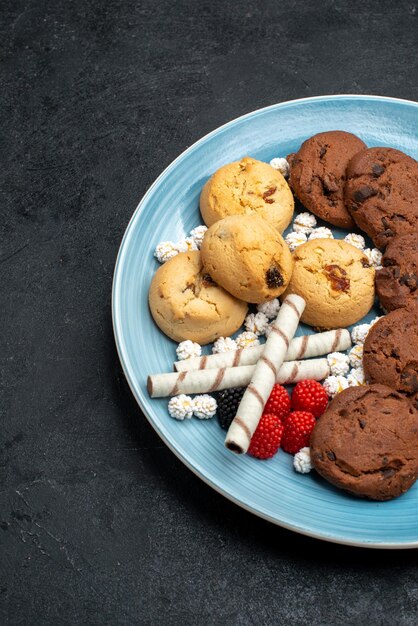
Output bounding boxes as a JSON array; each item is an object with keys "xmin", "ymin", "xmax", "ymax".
[{"xmin": 225, "ymin": 294, "xmax": 306, "ymax": 454}]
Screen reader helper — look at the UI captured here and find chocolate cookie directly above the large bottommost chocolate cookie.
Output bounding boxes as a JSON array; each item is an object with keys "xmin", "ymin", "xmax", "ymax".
[{"xmin": 363, "ymin": 305, "xmax": 418, "ymax": 408}]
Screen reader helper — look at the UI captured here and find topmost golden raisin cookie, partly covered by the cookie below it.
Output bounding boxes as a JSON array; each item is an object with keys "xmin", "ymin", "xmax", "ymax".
[{"xmin": 200, "ymin": 157, "xmax": 294, "ymax": 233}]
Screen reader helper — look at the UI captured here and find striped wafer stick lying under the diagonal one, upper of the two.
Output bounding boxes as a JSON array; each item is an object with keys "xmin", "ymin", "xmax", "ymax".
[{"xmin": 174, "ymin": 328, "xmax": 351, "ymax": 372}]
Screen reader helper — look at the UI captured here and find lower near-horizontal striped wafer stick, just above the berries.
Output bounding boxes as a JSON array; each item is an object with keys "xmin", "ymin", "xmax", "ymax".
[{"xmin": 147, "ymin": 359, "xmax": 330, "ymax": 398}]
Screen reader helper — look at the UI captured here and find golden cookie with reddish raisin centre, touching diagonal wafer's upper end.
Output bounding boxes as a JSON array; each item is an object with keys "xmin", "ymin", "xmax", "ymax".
[{"xmin": 283, "ymin": 239, "xmax": 375, "ymax": 329}]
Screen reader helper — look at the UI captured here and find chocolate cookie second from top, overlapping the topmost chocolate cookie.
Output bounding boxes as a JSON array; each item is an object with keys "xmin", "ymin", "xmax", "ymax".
[{"xmin": 344, "ymin": 148, "xmax": 418, "ymax": 249}]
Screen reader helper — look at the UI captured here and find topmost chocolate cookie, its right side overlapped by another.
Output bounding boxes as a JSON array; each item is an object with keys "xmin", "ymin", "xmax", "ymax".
[{"xmin": 288, "ymin": 130, "xmax": 366, "ymax": 228}]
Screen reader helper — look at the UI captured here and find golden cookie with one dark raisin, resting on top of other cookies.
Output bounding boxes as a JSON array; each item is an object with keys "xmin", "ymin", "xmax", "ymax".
[{"xmin": 201, "ymin": 214, "xmax": 293, "ymax": 303}]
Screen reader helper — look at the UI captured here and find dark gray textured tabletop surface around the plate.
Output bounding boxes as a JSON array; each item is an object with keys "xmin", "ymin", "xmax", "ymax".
[{"xmin": 0, "ymin": 0, "xmax": 418, "ymax": 626}]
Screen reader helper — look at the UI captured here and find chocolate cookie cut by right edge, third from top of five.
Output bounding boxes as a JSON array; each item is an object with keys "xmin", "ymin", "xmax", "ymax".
[{"xmin": 376, "ymin": 233, "xmax": 418, "ymax": 311}]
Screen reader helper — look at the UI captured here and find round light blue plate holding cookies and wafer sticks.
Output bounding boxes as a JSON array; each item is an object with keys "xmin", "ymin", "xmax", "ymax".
[{"xmin": 112, "ymin": 95, "xmax": 418, "ymax": 548}]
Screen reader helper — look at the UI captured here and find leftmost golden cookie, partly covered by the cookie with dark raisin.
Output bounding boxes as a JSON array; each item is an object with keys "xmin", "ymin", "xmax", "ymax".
[{"xmin": 149, "ymin": 250, "xmax": 248, "ymax": 345}]
